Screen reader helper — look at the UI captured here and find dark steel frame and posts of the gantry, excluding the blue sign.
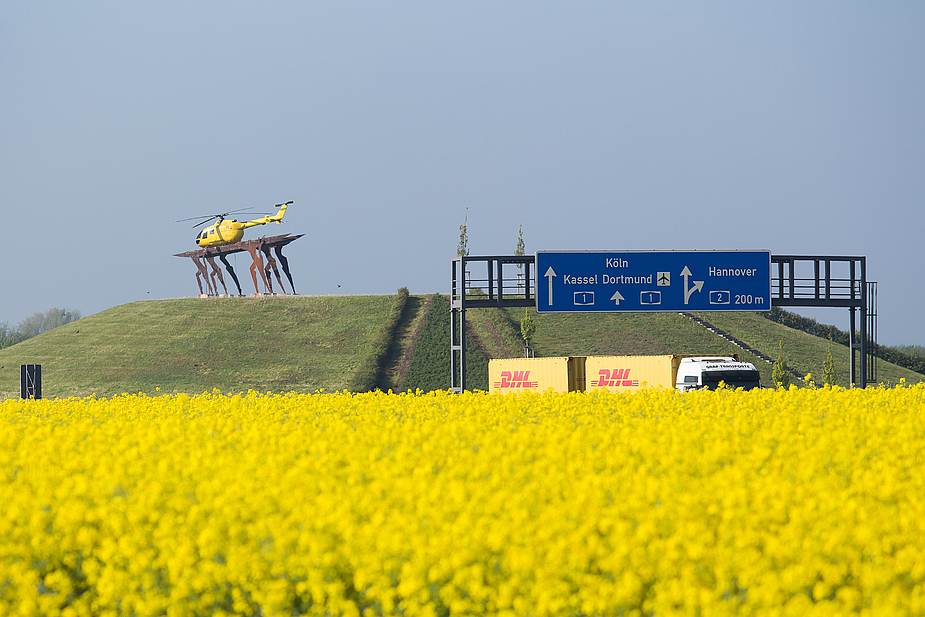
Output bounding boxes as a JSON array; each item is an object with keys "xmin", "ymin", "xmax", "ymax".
[{"xmin": 450, "ymin": 255, "xmax": 877, "ymax": 392}]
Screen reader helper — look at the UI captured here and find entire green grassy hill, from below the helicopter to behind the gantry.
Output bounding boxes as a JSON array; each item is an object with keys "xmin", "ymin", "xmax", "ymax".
[{"xmin": 0, "ymin": 294, "xmax": 925, "ymax": 398}]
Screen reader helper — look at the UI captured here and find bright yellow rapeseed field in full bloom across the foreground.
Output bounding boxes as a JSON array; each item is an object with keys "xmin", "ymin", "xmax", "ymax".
[{"xmin": 0, "ymin": 385, "xmax": 925, "ymax": 617}]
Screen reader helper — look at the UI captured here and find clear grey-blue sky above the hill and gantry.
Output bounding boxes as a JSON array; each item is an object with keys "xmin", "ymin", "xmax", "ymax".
[{"xmin": 0, "ymin": 0, "xmax": 925, "ymax": 345}]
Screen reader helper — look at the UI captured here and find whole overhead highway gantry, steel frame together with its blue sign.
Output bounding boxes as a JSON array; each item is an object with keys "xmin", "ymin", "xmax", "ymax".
[{"xmin": 450, "ymin": 251, "xmax": 877, "ymax": 392}]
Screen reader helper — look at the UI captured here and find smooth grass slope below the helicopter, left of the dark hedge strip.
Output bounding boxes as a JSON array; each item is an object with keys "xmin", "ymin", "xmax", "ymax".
[{"xmin": 0, "ymin": 296, "xmax": 394, "ymax": 398}]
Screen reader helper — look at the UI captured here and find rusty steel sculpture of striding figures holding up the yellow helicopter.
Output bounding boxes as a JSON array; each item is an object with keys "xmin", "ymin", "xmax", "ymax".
[{"xmin": 174, "ymin": 234, "xmax": 305, "ymax": 298}]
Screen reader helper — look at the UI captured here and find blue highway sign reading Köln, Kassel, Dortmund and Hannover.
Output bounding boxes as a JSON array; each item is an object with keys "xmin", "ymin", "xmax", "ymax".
[{"xmin": 535, "ymin": 251, "xmax": 771, "ymax": 313}]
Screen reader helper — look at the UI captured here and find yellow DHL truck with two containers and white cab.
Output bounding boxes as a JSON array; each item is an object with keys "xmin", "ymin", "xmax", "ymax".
[{"xmin": 488, "ymin": 354, "xmax": 761, "ymax": 392}]
